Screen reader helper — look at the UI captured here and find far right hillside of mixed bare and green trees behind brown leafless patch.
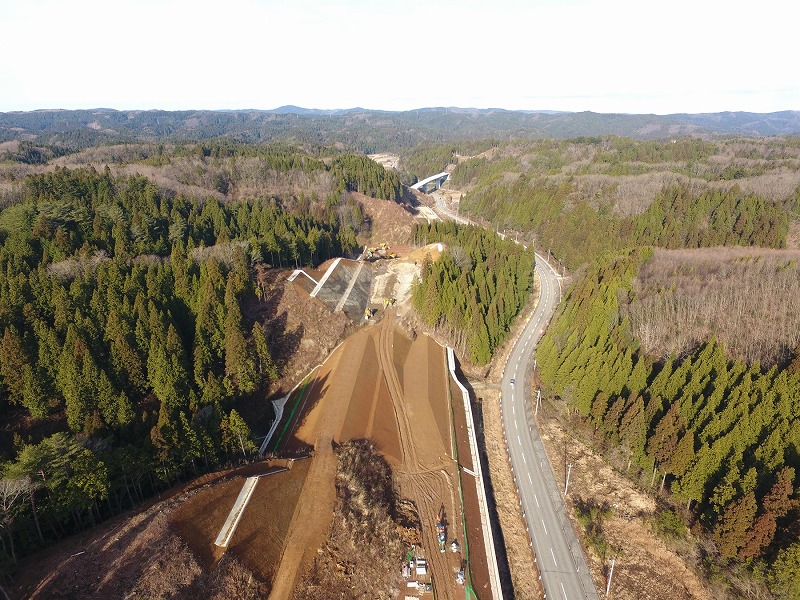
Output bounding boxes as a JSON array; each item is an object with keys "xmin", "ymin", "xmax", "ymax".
[{"xmin": 410, "ymin": 138, "xmax": 800, "ymax": 268}]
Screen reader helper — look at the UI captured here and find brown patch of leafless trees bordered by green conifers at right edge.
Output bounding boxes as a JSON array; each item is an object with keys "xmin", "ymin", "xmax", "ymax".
[{"xmin": 630, "ymin": 248, "xmax": 800, "ymax": 366}]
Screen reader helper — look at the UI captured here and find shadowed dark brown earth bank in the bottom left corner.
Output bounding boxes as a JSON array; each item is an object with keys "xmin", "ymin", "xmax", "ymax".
[{"xmin": 7, "ymin": 464, "xmax": 276, "ymax": 599}]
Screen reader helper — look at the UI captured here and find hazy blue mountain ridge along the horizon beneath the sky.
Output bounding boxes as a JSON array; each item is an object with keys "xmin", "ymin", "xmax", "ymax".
[{"xmin": 0, "ymin": 105, "xmax": 800, "ymax": 152}]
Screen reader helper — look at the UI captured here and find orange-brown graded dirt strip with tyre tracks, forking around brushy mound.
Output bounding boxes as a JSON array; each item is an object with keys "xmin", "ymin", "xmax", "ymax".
[{"xmin": 270, "ymin": 311, "xmax": 464, "ymax": 600}]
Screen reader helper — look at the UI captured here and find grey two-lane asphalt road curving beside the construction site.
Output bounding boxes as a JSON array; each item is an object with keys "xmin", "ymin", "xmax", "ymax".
[{"xmin": 501, "ymin": 255, "xmax": 598, "ymax": 600}]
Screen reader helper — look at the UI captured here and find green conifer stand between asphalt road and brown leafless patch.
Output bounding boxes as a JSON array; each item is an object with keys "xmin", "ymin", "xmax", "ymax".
[{"xmin": 537, "ymin": 251, "xmax": 800, "ymax": 596}]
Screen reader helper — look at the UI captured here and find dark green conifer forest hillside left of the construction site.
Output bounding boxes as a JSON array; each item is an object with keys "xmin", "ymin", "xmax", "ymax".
[{"xmin": 0, "ymin": 154, "xmax": 399, "ymax": 573}]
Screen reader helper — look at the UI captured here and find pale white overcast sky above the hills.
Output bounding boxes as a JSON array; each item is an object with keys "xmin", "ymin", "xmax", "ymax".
[{"xmin": 0, "ymin": 0, "xmax": 800, "ymax": 114}]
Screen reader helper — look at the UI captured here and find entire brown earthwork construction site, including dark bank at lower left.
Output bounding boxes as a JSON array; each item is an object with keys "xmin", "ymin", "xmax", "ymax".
[{"xmin": 9, "ymin": 238, "xmax": 499, "ymax": 600}]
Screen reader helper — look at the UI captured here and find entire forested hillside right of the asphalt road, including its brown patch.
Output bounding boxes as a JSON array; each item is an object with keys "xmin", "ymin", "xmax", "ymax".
[{"xmin": 412, "ymin": 138, "xmax": 800, "ymax": 597}]
